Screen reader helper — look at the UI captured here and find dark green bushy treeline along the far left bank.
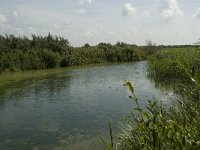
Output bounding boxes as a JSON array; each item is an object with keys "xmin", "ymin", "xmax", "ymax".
[{"xmin": 0, "ymin": 34, "xmax": 150, "ymax": 73}]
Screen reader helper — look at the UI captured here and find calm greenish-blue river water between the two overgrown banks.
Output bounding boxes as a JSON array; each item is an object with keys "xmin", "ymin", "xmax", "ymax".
[{"xmin": 0, "ymin": 61, "xmax": 172, "ymax": 150}]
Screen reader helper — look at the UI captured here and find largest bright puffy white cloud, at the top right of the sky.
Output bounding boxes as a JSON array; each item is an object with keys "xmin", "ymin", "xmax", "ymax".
[{"xmin": 157, "ymin": 0, "xmax": 182, "ymax": 19}]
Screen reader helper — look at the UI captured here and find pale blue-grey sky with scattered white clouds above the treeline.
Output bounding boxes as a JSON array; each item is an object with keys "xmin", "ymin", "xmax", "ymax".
[{"xmin": 0, "ymin": 0, "xmax": 200, "ymax": 46}]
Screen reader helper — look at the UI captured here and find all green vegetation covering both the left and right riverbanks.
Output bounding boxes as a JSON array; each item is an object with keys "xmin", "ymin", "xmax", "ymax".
[{"xmin": 0, "ymin": 34, "xmax": 200, "ymax": 150}]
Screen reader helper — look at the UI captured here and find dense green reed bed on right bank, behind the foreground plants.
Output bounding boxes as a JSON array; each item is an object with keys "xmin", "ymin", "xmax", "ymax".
[{"xmin": 148, "ymin": 47, "xmax": 200, "ymax": 79}]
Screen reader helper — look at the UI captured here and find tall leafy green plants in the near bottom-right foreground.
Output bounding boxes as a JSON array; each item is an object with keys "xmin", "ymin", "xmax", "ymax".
[{"xmin": 104, "ymin": 75, "xmax": 200, "ymax": 150}]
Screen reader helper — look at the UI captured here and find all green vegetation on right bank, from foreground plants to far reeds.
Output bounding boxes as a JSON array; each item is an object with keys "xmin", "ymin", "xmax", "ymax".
[{"xmin": 104, "ymin": 47, "xmax": 200, "ymax": 150}]
